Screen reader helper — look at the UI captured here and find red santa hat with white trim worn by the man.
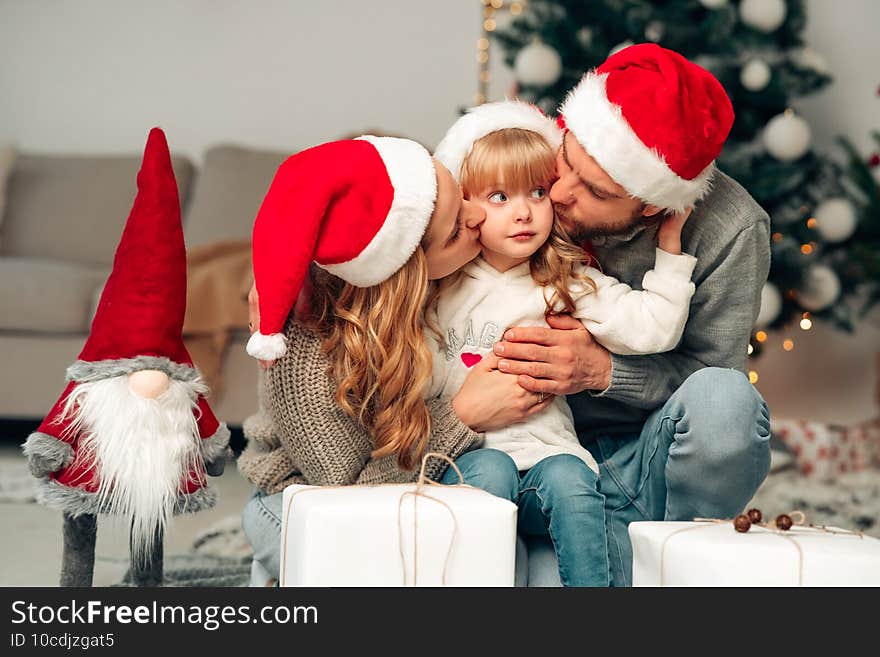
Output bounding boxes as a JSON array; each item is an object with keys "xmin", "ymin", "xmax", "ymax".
[{"xmin": 559, "ymin": 44, "xmax": 733, "ymax": 211}]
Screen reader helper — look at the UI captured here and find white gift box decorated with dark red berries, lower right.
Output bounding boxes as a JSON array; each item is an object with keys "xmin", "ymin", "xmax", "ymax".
[{"xmin": 629, "ymin": 521, "xmax": 880, "ymax": 586}]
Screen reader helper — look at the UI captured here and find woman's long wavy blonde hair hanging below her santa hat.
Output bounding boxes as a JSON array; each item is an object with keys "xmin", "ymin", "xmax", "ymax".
[{"xmin": 304, "ymin": 246, "xmax": 431, "ymax": 470}]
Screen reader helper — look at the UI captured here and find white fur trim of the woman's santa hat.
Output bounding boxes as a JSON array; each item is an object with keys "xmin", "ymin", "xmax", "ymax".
[{"xmin": 317, "ymin": 135, "xmax": 437, "ymax": 287}]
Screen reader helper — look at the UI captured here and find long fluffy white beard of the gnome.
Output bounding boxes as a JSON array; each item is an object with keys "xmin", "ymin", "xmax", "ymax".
[{"xmin": 64, "ymin": 376, "xmax": 206, "ymax": 559}]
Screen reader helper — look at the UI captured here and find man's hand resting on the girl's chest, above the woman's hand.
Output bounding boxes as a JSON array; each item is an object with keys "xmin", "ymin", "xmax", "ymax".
[{"xmin": 495, "ymin": 315, "xmax": 611, "ymax": 395}]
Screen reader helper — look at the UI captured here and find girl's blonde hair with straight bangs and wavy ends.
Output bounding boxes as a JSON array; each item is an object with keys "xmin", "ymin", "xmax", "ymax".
[{"xmin": 438, "ymin": 128, "xmax": 596, "ymax": 314}]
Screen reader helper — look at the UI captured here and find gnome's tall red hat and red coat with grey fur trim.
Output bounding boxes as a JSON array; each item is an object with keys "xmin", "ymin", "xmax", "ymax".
[{"xmin": 24, "ymin": 128, "xmax": 229, "ymax": 515}]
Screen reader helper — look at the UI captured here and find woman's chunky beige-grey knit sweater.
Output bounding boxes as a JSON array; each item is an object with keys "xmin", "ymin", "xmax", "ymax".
[{"xmin": 238, "ymin": 321, "xmax": 482, "ymax": 494}]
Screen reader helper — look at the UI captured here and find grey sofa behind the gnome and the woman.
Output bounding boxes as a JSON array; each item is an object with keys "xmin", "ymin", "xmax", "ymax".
[{"xmin": 0, "ymin": 145, "xmax": 287, "ymax": 425}]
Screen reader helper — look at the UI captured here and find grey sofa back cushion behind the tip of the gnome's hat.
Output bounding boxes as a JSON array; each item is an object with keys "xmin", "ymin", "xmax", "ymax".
[{"xmin": 0, "ymin": 154, "xmax": 194, "ymax": 265}]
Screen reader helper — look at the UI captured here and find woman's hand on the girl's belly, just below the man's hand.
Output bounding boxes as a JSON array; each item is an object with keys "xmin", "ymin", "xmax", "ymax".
[{"xmin": 452, "ymin": 354, "xmax": 554, "ymax": 433}]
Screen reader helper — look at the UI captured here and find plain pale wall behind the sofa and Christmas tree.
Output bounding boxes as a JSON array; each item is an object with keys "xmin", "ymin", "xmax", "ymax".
[{"xmin": 0, "ymin": 0, "xmax": 880, "ymax": 421}]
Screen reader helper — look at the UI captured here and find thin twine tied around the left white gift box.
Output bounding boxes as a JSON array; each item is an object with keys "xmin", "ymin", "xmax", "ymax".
[{"xmin": 279, "ymin": 452, "xmax": 479, "ymax": 586}]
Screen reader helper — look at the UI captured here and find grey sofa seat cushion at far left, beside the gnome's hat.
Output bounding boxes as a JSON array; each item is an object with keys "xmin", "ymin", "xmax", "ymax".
[{"xmin": 0, "ymin": 258, "xmax": 110, "ymax": 334}]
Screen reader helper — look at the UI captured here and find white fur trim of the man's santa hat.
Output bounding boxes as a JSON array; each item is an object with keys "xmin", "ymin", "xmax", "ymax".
[{"xmin": 559, "ymin": 73, "xmax": 715, "ymax": 212}]
